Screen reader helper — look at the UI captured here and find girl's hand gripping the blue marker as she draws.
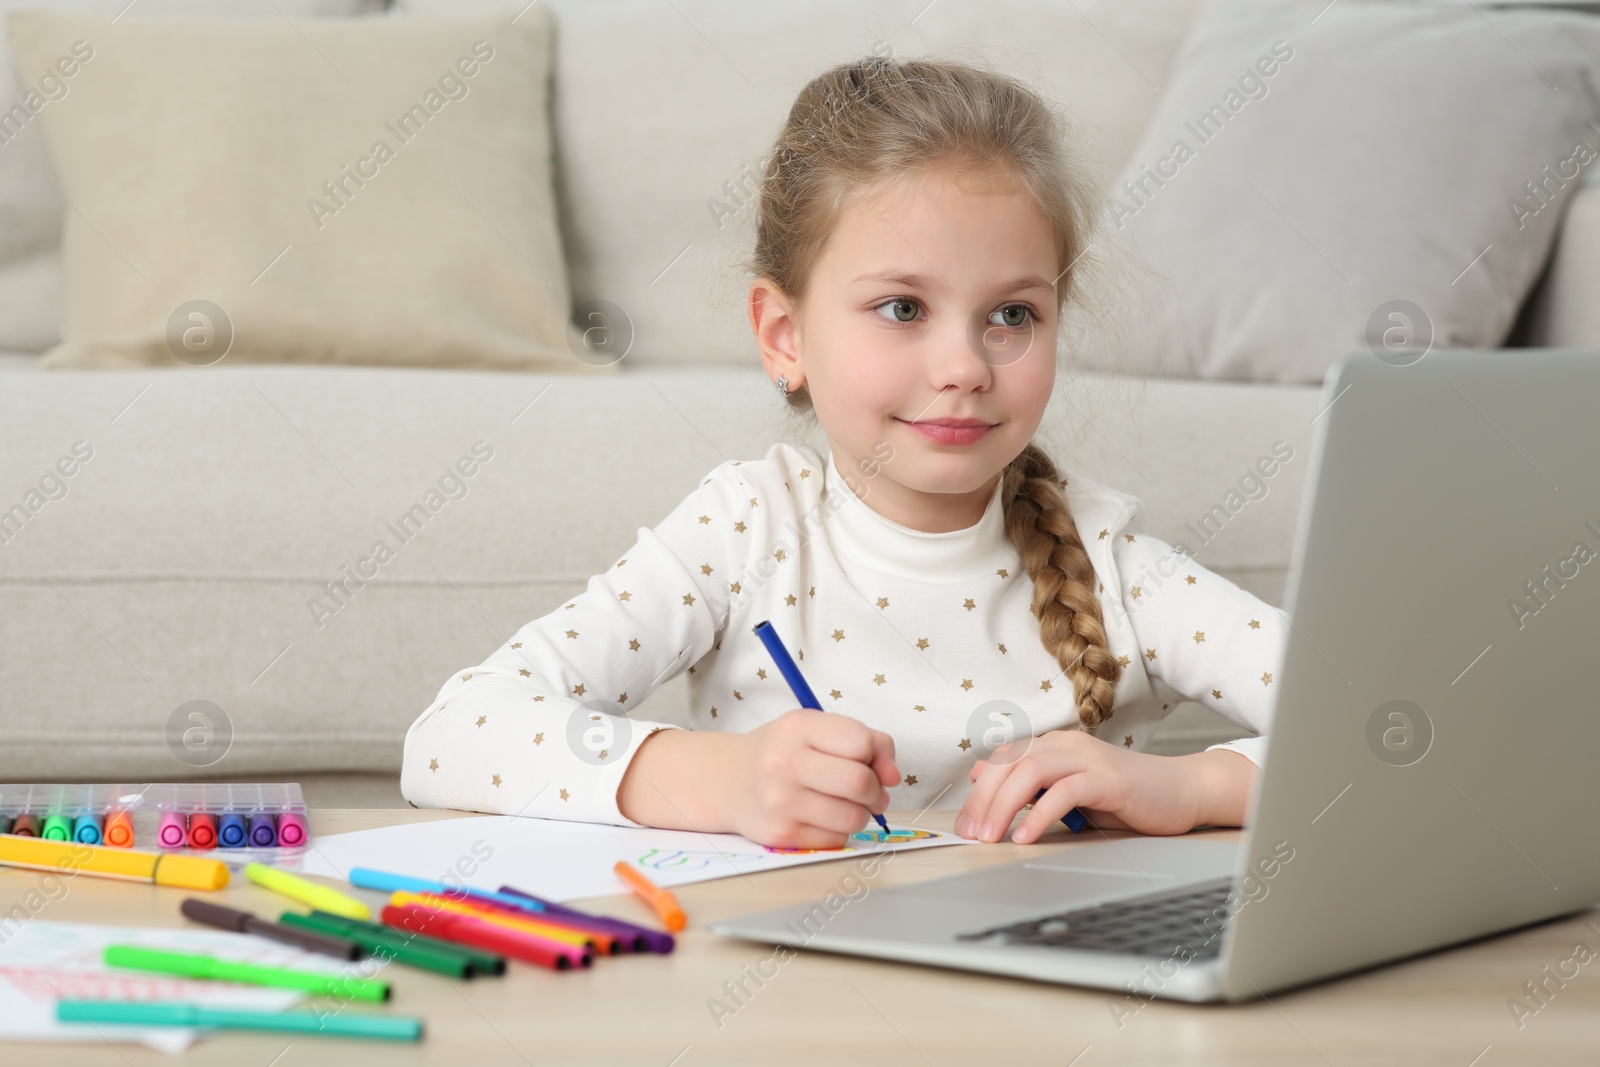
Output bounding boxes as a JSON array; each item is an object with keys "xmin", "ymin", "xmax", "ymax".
[{"xmin": 723, "ymin": 707, "xmax": 901, "ymax": 848}]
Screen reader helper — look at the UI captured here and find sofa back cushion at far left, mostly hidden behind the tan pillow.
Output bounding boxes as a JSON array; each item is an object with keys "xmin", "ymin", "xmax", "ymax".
[{"xmin": 0, "ymin": 0, "xmax": 384, "ymax": 352}]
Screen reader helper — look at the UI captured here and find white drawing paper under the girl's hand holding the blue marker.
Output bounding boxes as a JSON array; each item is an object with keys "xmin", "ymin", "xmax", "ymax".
[{"xmin": 301, "ymin": 816, "xmax": 971, "ymax": 902}]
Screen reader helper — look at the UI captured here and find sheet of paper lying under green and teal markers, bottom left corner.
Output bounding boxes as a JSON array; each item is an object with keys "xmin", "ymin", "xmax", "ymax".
[{"xmin": 0, "ymin": 918, "xmax": 372, "ymax": 1059}]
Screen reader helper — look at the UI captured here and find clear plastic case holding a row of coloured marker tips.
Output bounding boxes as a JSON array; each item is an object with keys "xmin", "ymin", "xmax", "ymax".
[{"xmin": 0, "ymin": 782, "xmax": 310, "ymax": 864}]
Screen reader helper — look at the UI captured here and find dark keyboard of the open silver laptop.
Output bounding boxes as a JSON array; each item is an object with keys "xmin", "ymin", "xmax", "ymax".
[{"xmin": 955, "ymin": 878, "xmax": 1234, "ymax": 960}]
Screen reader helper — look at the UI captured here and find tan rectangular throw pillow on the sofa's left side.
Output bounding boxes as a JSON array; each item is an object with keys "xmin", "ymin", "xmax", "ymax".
[{"xmin": 11, "ymin": 6, "xmax": 590, "ymax": 371}]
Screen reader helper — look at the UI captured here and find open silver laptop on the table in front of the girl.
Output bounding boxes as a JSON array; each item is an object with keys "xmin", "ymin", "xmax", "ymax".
[{"xmin": 710, "ymin": 349, "xmax": 1600, "ymax": 1013}]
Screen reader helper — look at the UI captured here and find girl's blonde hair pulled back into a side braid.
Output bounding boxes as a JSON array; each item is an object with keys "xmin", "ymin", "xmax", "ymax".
[{"xmin": 749, "ymin": 56, "xmax": 1120, "ymax": 731}]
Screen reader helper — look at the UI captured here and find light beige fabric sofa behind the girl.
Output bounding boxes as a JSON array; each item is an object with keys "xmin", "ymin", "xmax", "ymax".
[{"xmin": 0, "ymin": 0, "xmax": 1600, "ymax": 805}]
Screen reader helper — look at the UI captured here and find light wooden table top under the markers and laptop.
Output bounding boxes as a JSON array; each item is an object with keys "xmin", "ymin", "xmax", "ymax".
[{"xmin": 0, "ymin": 809, "xmax": 1600, "ymax": 1067}]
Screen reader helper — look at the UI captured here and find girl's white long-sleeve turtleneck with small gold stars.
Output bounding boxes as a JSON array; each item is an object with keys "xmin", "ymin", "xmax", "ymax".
[{"xmin": 400, "ymin": 443, "xmax": 1288, "ymax": 825}]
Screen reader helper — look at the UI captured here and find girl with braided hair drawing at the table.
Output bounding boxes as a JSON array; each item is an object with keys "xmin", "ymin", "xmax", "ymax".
[{"xmin": 402, "ymin": 58, "xmax": 1288, "ymax": 848}]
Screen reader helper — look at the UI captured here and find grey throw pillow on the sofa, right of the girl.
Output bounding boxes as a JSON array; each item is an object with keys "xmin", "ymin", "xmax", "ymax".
[{"xmin": 1074, "ymin": 0, "xmax": 1600, "ymax": 382}]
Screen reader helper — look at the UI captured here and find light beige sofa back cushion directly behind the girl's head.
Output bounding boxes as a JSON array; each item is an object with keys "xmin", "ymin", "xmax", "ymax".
[{"xmin": 398, "ymin": 0, "xmax": 1198, "ymax": 365}]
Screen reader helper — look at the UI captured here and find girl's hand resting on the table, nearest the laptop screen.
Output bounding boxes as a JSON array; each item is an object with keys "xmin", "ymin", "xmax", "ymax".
[{"xmin": 955, "ymin": 729, "xmax": 1200, "ymax": 845}]
